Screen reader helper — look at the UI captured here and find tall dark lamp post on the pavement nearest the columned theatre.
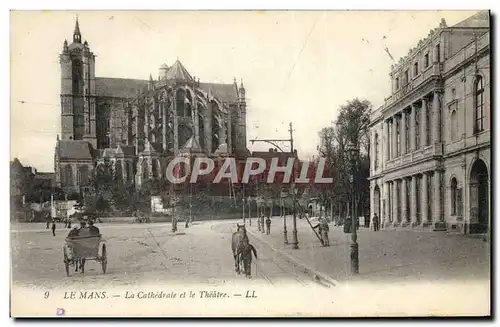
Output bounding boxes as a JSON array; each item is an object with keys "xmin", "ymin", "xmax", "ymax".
[{"xmin": 346, "ymin": 142, "xmax": 359, "ymax": 274}]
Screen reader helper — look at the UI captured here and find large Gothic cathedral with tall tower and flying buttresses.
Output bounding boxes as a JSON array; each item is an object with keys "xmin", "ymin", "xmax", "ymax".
[{"xmin": 54, "ymin": 19, "xmax": 249, "ymax": 194}]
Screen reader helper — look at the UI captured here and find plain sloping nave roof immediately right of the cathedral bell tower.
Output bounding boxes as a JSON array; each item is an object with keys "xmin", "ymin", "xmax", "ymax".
[{"xmin": 95, "ymin": 77, "xmax": 148, "ymax": 98}]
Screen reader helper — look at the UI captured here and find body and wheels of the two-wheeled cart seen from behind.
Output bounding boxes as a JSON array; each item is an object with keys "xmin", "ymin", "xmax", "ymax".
[{"xmin": 63, "ymin": 235, "xmax": 108, "ymax": 276}]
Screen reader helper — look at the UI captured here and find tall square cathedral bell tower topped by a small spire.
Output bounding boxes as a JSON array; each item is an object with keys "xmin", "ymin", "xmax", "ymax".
[{"xmin": 59, "ymin": 18, "xmax": 97, "ymax": 148}]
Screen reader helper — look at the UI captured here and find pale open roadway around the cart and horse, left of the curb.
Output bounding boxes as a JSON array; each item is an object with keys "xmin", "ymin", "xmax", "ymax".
[{"xmin": 11, "ymin": 221, "xmax": 313, "ymax": 288}]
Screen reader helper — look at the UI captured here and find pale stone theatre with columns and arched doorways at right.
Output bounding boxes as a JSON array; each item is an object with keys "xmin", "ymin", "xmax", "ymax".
[{"xmin": 370, "ymin": 11, "xmax": 492, "ymax": 233}]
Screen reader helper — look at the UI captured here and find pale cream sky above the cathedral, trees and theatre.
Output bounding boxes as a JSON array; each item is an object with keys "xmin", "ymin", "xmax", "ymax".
[{"xmin": 10, "ymin": 11, "xmax": 475, "ymax": 172}]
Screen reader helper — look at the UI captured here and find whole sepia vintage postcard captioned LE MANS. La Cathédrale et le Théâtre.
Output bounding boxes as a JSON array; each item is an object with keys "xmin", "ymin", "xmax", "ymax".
[{"xmin": 10, "ymin": 9, "xmax": 493, "ymax": 317}]
